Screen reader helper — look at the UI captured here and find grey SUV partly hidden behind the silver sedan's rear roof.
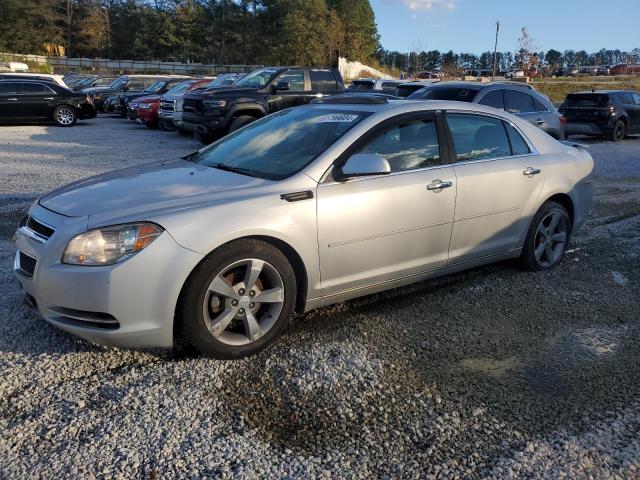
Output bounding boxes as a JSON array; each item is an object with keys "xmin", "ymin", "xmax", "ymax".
[{"xmin": 407, "ymin": 82, "xmax": 565, "ymax": 140}]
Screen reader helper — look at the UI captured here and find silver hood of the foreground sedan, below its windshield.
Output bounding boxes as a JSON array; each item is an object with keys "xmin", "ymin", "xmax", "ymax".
[{"xmin": 39, "ymin": 160, "xmax": 272, "ymax": 219}]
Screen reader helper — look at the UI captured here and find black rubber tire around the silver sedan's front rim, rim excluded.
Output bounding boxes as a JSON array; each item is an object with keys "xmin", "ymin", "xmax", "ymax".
[{"xmin": 178, "ymin": 239, "xmax": 297, "ymax": 359}]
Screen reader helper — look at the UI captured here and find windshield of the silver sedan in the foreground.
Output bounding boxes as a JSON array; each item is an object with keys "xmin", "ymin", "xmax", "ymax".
[{"xmin": 187, "ymin": 108, "xmax": 370, "ymax": 180}]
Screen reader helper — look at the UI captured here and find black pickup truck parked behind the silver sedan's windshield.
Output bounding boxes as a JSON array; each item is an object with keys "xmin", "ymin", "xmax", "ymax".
[{"xmin": 182, "ymin": 67, "xmax": 345, "ymax": 143}]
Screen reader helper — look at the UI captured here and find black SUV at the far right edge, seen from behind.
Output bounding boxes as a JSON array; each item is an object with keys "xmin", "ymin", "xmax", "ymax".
[{"xmin": 559, "ymin": 90, "xmax": 640, "ymax": 142}]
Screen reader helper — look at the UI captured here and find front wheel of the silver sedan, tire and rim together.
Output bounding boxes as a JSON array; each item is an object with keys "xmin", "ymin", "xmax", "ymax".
[{"xmin": 176, "ymin": 239, "xmax": 297, "ymax": 359}]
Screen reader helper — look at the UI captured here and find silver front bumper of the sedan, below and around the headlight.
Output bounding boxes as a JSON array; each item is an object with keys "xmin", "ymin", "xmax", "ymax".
[{"xmin": 14, "ymin": 205, "xmax": 202, "ymax": 348}]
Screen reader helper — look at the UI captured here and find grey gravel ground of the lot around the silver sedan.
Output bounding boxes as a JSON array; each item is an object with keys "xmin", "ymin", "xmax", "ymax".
[{"xmin": 0, "ymin": 118, "xmax": 640, "ymax": 479}]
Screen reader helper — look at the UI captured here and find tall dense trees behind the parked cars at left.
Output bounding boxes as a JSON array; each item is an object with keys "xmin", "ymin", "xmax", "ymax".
[{"xmin": 0, "ymin": 0, "xmax": 379, "ymax": 65}]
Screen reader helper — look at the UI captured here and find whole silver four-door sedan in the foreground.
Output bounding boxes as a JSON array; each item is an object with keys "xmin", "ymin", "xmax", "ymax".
[{"xmin": 14, "ymin": 97, "xmax": 593, "ymax": 358}]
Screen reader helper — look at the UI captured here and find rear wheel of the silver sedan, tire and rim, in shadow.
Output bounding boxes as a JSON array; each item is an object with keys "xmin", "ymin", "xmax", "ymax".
[{"xmin": 520, "ymin": 201, "xmax": 571, "ymax": 272}]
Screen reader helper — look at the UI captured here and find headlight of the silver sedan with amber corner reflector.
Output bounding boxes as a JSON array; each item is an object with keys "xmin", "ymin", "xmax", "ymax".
[{"xmin": 62, "ymin": 223, "xmax": 162, "ymax": 266}]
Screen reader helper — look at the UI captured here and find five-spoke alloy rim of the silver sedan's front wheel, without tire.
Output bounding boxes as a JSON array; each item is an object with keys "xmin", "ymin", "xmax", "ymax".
[{"xmin": 202, "ymin": 258, "xmax": 284, "ymax": 346}]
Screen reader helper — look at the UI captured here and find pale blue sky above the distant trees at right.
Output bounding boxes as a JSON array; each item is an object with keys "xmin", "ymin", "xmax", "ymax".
[{"xmin": 371, "ymin": 0, "xmax": 640, "ymax": 53}]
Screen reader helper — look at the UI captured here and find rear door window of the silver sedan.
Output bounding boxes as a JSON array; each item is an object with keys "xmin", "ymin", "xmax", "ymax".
[{"xmin": 446, "ymin": 113, "xmax": 511, "ymax": 162}]
